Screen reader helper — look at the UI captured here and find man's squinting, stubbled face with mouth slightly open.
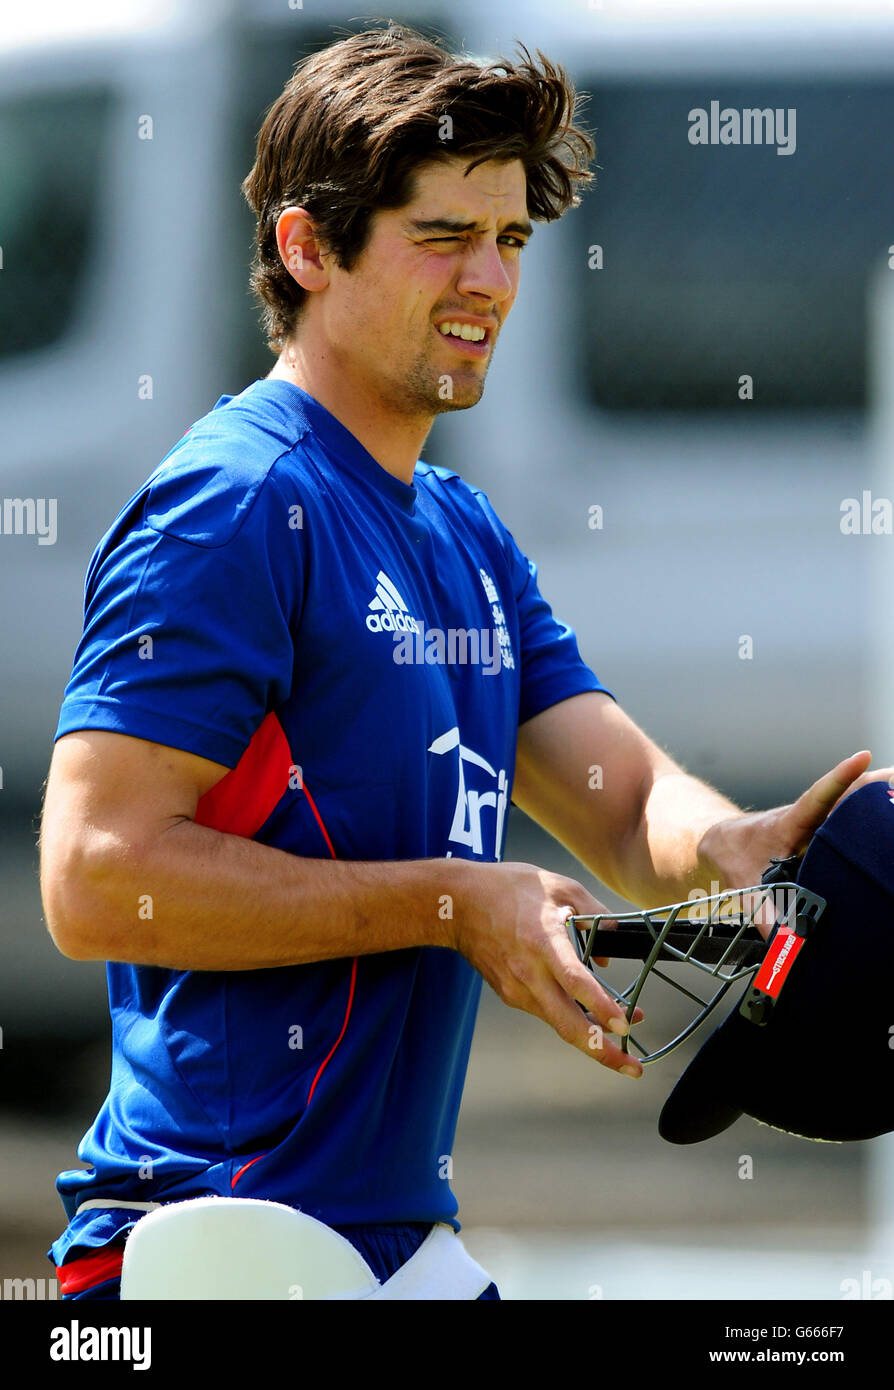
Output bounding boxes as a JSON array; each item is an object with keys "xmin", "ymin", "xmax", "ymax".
[{"xmin": 314, "ymin": 157, "xmax": 531, "ymax": 417}]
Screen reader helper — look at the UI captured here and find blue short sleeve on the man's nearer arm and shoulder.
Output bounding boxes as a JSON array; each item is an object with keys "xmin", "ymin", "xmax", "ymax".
[{"xmin": 56, "ymin": 468, "xmax": 304, "ymax": 767}]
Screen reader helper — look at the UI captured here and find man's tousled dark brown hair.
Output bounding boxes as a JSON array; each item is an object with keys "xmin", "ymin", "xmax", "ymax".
[{"xmin": 242, "ymin": 22, "xmax": 595, "ymax": 353}]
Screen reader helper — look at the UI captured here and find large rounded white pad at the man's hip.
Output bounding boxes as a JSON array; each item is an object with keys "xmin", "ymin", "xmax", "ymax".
[{"xmin": 121, "ymin": 1197, "xmax": 380, "ymax": 1300}]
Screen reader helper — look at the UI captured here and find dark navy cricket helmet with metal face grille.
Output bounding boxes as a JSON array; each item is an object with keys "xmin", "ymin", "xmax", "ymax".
[{"xmin": 569, "ymin": 783, "xmax": 894, "ymax": 1144}]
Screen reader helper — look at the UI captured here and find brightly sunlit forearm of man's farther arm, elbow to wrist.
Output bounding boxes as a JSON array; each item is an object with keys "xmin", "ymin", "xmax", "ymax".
[{"xmin": 612, "ymin": 770, "xmax": 744, "ymax": 908}]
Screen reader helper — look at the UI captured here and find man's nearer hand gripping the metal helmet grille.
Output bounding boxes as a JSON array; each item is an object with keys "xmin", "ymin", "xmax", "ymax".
[{"xmin": 450, "ymin": 863, "xmax": 642, "ymax": 1077}]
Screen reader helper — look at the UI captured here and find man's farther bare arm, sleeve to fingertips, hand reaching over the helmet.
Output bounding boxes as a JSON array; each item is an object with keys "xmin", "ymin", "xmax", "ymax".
[{"xmin": 513, "ymin": 691, "xmax": 890, "ymax": 908}]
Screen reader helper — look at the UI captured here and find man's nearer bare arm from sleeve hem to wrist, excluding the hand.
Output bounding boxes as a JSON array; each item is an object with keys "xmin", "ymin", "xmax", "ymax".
[{"xmin": 40, "ymin": 730, "xmax": 464, "ymax": 970}]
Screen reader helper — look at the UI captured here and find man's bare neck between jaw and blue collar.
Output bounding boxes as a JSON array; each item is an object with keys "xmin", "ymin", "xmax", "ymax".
[{"xmin": 268, "ymin": 343, "xmax": 432, "ymax": 484}]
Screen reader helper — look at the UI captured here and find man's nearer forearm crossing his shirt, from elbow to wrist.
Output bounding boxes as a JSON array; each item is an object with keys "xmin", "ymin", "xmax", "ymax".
[{"xmin": 57, "ymin": 820, "xmax": 475, "ymax": 970}]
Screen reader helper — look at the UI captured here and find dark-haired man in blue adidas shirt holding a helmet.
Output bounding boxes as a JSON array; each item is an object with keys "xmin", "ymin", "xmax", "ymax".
[{"xmin": 42, "ymin": 26, "xmax": 869, "ymax": 1298}]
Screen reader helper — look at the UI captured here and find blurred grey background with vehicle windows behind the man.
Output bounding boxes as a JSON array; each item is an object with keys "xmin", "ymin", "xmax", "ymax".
[{"xmin": 0, "ymin": 0, "xmax": 894, "ymax": 1300}]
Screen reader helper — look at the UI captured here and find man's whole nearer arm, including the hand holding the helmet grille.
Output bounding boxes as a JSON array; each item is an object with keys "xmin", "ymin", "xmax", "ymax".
[{"xmin": 40, "ymin": 730, "xmax": 642, "ymax": 1076}]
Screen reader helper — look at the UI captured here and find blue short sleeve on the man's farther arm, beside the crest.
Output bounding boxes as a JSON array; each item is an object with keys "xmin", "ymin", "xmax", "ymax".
[{"xmin": 476, "ymin": 489, "xmax": 615, "ymax": 724}]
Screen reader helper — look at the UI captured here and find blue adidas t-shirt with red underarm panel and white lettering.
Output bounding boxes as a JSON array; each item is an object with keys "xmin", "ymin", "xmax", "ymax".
[{"xmin": 50, "ymin": 379, "xmax": 605, "ymax": 1264}]
